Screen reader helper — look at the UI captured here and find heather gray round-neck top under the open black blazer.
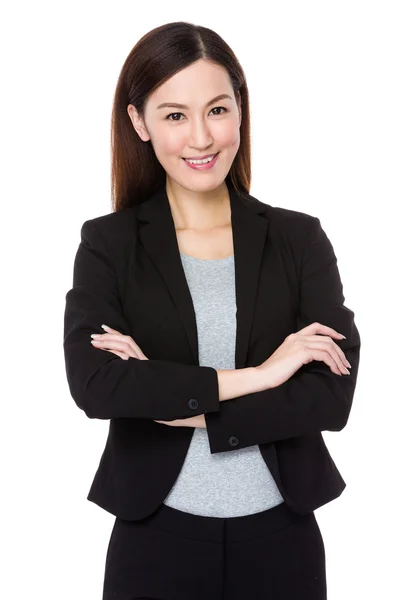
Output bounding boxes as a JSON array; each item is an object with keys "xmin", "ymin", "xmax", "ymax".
[{"xmin": 164, "ymin": 252, "xmax": 284, "ymax": 517}]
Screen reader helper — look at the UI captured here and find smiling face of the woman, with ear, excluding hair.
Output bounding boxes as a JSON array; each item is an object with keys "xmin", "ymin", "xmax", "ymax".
[{"xmin": 128, "ymin": 60, "xmax": 241, "ymax": 191}]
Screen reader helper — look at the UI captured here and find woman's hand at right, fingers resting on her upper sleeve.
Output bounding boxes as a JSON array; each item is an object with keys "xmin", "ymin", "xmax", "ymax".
[{"xmin": 256, "ymin": 323, "xmax": 351, "ymax": 387}]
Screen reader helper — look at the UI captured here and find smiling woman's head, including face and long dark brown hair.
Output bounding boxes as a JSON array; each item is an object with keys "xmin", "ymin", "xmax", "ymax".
[{"xmin": 108, "ymin": 22, "xmax": 251, "ymax": 214}]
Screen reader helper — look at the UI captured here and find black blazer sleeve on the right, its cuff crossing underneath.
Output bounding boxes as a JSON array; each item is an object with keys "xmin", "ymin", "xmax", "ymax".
[{"xmin": 205, "ymin": 217, "xmax": 361, "ymax": 454}]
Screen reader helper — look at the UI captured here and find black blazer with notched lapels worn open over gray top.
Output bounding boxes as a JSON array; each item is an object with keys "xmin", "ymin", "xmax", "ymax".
[{"xmin": 63, "ymin": 183, "xmax": 360, "ymax": 520}]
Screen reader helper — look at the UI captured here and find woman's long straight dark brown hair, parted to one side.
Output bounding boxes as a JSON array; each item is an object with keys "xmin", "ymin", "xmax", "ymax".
[{"xmin": 111, "ymin": 21, "xmax": 251, "ymax": 211}]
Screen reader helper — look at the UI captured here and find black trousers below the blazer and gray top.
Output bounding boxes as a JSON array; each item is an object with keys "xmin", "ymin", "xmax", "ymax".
[{"xmin": 103, "ymin": 503, "xmax": 327, "ymax": 600}]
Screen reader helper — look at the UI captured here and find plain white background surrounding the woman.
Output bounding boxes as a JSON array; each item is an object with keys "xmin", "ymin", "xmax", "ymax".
[{"xmin": 0, "ymin": 0, "xmax": 417, "ymax": 600}]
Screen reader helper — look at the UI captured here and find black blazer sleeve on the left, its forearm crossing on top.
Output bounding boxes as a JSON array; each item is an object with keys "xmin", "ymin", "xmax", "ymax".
[{"xmin": 63, "ymin": 219, "xmax": 220, "ymax": 420}]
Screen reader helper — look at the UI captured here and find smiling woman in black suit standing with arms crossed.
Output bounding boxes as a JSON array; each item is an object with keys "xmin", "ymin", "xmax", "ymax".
[{"xmin": 64, "ymin": 22, "xmax": 360, "ymax": 600}]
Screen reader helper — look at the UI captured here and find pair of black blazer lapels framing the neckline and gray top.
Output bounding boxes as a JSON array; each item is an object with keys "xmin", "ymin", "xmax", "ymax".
[{"xmin": 137, "ymin": 183, "xmax": 268, "ymax": 369}]
